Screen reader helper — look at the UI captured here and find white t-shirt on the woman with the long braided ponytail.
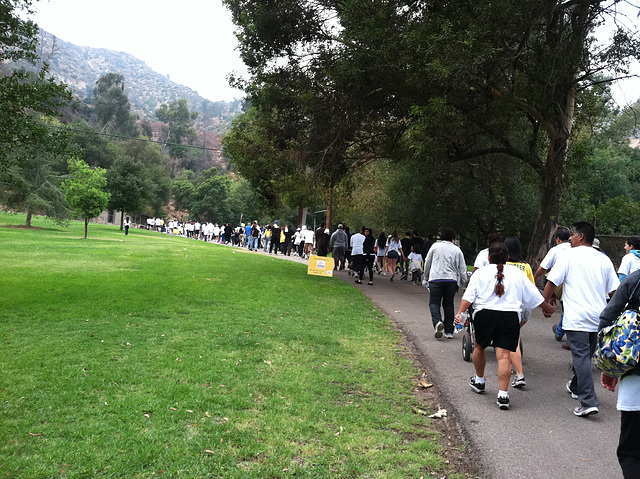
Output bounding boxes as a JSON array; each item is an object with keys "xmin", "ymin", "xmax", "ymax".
[{"xmin": 462, "ymin": 264, "xmax": 544, "ymax": 314}]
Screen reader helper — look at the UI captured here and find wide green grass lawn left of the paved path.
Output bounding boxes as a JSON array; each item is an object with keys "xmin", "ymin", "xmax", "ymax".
[{"xmin": 0, "ymin": 214, "xmax": 461, "ymax": 479}]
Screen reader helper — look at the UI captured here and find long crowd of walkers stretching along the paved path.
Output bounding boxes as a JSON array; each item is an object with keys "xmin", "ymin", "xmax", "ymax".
[{"xmin": 141, "ymin": 219, "xmax": 640, "ymax": 478}]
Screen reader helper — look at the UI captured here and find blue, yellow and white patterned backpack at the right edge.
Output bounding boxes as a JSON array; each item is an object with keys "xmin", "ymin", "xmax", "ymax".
[{"xmin": 593, "ymin": 281, "xmax": 640, "ymax": 378}]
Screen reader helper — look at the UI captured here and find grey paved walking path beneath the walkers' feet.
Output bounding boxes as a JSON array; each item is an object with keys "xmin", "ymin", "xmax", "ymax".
[{"xmin": 239, "ymin": 249, "xmax": 622, "ymax": 479}]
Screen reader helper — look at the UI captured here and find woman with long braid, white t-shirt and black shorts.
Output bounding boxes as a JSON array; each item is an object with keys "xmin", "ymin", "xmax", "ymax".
[{"xmin": 456, "ymin": 243, "xmax": 555, "ymax": 410}]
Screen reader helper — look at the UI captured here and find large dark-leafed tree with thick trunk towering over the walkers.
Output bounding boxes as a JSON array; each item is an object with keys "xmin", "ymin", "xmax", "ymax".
[{"xmin": 225, "ymin": 0, "xmax": 638, "ymax": 262}]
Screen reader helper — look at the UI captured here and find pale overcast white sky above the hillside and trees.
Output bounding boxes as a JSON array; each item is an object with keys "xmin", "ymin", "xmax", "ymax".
[{"xmin": 32, "ymin": 0, "xmax": 640, "ymax": 106}]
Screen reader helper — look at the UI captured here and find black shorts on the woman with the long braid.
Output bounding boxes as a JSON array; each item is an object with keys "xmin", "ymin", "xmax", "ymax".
[{"xmin": 473, "ymin": 309, "xmax": 520, "ymax": 351}]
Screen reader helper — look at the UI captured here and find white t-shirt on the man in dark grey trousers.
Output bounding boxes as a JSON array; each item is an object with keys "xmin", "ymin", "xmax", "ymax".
[{"xmin": 547, "ymin": 246, "xmax": 620, "ymax": 332}]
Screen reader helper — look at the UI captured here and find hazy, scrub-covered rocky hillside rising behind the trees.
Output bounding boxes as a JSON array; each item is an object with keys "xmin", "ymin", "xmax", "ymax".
[{"xmin": 17, "ymin": 30, "xmax": 242, "ymax": 131}]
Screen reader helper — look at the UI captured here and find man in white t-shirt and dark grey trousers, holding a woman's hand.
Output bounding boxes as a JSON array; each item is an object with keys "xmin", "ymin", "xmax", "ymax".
[{"xmin": 543, "ymin": 222, "xmax": 620, "ymax": 417}]
